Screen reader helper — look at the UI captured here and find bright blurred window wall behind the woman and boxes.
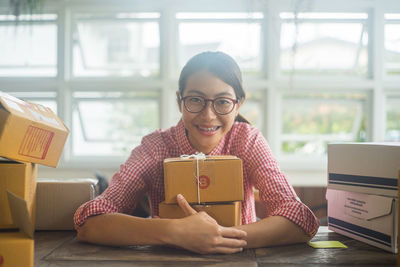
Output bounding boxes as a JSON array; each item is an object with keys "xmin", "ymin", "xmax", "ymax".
[{"xmin": 0, "ymin": 0, "xmax": 400, "ymax": 223}]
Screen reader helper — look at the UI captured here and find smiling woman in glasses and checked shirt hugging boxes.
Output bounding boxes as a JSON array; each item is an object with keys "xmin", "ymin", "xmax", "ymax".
[{"xmin": 74, "ymin": 52, "xmax": 319, "ymax": 253}]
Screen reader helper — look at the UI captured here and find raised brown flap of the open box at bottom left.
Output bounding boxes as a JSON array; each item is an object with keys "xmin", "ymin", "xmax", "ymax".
[{"xmin": 7, "ymin": 190, "xmax": 34, "ymax": 238}]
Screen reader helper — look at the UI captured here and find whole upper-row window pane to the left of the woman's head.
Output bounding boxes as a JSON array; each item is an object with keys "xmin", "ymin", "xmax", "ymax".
[{"xmin": 73, "ymin": 13, "xmax": 160, "ymax": 77}]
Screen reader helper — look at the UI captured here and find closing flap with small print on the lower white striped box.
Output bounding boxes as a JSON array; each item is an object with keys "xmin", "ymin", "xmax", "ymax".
[{"xmin": 345, "ymin": 192, "xmax": 394, "ymax": 220}]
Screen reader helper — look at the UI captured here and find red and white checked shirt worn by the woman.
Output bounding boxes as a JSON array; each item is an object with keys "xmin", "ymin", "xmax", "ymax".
[{"xmin": 74, "ymin": 120, "xmax": 319, "ymax": 236}]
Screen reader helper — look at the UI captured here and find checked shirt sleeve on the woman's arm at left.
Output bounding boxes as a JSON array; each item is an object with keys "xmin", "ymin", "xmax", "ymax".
[{"xmin": 74, "ymin": 134, "xmax": 159, "ymax": 229}]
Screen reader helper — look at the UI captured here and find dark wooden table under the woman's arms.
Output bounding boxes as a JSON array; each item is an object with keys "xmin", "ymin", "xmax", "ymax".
[{"xmin": 35, "ymin": 227, "xmax": 397, "ymax": 267}]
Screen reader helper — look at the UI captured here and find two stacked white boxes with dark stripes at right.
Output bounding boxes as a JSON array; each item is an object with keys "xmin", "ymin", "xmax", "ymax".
[{"xmin": 326, "ymin": 143, "xmax": 400, "ymax": 253}]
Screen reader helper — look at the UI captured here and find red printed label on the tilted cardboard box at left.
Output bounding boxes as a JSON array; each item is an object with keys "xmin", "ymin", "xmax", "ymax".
[{"xmin": 18, "ymin": 126, "xmax": 54, "ymax": 159}]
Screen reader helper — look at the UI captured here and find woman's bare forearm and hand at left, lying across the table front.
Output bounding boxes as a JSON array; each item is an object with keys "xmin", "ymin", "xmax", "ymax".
[{"xmin": 77, "ymin": 197, "xmax": 247, "ymax": 254}]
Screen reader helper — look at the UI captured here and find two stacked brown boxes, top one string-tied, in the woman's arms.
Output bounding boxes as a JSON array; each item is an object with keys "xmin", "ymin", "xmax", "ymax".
[{"xmin": 159, "ymin": 156, "xmax": 244, "ymax": 226}]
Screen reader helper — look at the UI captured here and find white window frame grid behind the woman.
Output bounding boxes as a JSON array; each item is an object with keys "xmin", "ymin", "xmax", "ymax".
[{"xmin": 0, "ymin": 0, "xmax": 400, "ymax": 170}]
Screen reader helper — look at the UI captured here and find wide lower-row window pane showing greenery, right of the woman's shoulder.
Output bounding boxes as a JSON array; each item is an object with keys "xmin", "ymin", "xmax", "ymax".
[{"xmin": 281, "ymin": 93, "xmax": 368, "ymax": 156}]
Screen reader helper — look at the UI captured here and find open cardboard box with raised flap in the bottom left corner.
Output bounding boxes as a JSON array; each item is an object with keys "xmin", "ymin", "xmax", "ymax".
[{"xmin": 0, "ymin": 191, "xmax": 34, "ymax": 267}]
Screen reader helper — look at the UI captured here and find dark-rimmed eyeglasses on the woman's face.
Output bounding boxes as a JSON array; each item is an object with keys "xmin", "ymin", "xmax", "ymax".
[{"xmin": 181, "ymin": 96, "xmax": 237, "ymax": 115}]
